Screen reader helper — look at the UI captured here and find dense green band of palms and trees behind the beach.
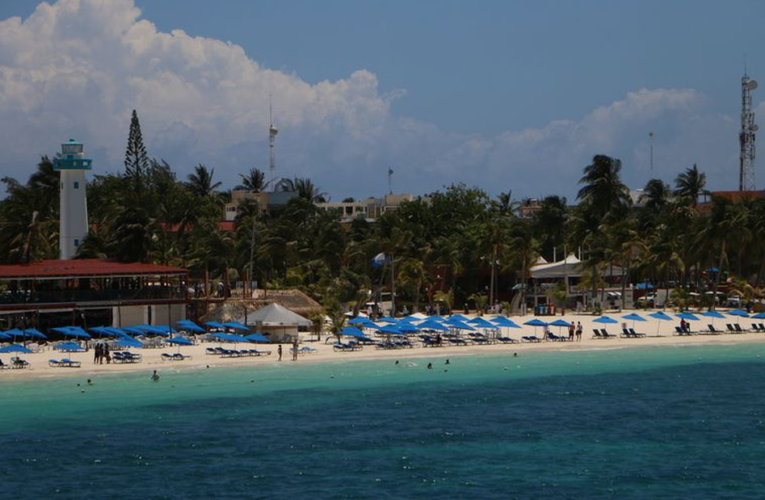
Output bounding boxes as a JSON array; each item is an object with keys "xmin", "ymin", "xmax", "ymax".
[{"xmin": 0, "ymin": 112, "xmax": 765, "ymax": 309}]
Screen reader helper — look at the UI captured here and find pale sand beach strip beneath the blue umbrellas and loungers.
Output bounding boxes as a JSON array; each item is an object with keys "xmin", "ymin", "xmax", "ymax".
[{"xmin": 0, "ymin": 312, "xmax": 765, "ymax": 383}]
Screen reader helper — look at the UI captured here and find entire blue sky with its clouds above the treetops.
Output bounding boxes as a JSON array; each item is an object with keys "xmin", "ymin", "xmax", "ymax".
[{"xmin": 0, "ymin": 0, "xmax": 765, "ymax": 201}]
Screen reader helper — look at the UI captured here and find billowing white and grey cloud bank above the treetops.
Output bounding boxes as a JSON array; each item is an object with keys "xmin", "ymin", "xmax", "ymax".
[{"xmin": 0, "ymin": 0, "xmax": 752, "ymax": 198}]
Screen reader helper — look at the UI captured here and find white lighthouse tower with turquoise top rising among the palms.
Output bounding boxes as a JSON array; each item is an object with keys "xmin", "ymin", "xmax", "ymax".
[{"xmin": 54, "ymin": 139, "xmax": 93, "ymax": 260}]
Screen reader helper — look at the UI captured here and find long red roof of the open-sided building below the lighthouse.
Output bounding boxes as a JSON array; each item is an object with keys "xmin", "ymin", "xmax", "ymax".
[{"xmin": 0, "ymin": 259, "xmax": 186, "ymax": 280}]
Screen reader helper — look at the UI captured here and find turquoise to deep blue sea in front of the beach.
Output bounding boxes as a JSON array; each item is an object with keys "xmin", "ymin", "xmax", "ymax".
[{"xmin": 0, "ymin": 345, "xmax": 765, "ymax": 499}]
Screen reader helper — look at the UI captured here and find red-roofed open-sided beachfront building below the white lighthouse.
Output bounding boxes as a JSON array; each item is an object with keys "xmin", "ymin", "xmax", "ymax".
[{"xmin": 0, "ymin": 259, "xmax": 188, "ymax": 330}]
